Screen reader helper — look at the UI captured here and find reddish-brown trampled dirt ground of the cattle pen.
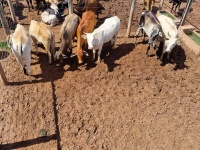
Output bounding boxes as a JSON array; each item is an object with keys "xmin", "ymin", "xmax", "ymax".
[{"xmin": 0, "ymin": 0, "xmax": 200, "ymax": 150}]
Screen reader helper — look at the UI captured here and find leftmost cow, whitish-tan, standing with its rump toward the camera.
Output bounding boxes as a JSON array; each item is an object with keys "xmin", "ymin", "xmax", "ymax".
[{"xmin": 7, "ymin": 24, "xmax": 32, "ymax": 82}]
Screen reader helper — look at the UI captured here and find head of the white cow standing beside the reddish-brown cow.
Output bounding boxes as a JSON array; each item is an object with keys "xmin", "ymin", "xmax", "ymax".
[{"xmin": 81, "ymin": 33, "xmax": 99, "ymax": 50}]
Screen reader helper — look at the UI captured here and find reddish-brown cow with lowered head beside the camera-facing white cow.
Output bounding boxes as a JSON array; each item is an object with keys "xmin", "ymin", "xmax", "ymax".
[{"xmin": 76, "ymin": 11, "xmax": 97, "ymax": 64}]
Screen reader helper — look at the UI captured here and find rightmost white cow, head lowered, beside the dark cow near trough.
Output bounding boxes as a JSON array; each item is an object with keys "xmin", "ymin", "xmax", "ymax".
[{"xmin": 158, "ymin": 15, "xmax": 180, "ymax": 60}]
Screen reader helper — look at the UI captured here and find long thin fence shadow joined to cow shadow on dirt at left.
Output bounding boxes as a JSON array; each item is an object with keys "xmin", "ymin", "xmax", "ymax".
[{"xmin": 7, "ymin": 44, "xmax": 65, "ymax": 150}]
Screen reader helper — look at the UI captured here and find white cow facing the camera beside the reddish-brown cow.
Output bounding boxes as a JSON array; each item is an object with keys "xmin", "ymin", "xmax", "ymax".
[{"xmin": 82, "ymin": 16, "xmax": 120, "ymax": 63}]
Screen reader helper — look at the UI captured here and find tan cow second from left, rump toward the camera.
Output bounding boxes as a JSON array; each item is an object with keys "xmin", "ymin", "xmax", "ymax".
[{"xmin": 29, "ymin": 20, "xmax": 55, "ymax": 64}]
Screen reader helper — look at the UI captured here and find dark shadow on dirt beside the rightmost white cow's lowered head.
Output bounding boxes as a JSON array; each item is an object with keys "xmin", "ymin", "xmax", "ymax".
[{"xmin": 161, "ymin": 45, "xmax": 189, "ymax": 70}]
